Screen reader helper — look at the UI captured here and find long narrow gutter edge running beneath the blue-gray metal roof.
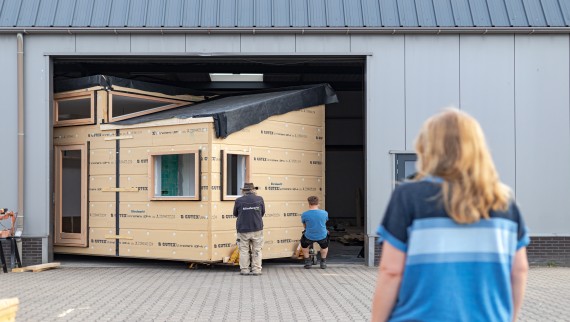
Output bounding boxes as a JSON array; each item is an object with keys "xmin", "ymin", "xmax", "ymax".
[{"xmin": 0, "ymin": 27, "xmax": 570, "ymax": 35}]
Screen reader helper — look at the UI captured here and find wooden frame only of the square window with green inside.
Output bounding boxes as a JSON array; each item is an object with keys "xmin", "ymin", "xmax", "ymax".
[{"xmin": 148, "ymin": 149, "xmax": 202, "ymax": 201}]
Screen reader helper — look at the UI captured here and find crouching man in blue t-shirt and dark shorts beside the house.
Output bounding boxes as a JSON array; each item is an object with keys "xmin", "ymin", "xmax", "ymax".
[{"xmin": 301, "ymin": 196, "xmax": 330, "ymax": 269}]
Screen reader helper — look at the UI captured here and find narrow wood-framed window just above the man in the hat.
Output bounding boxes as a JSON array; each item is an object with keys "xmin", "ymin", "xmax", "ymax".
[{"xmin": 222, "ymin": 151, "xmax": 250, "ymax": 200}]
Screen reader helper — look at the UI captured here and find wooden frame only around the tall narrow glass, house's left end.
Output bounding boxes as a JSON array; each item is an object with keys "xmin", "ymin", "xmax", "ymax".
[{"xmin": 54, "ymin": 144, "xmax": 88, "ymax": 247}]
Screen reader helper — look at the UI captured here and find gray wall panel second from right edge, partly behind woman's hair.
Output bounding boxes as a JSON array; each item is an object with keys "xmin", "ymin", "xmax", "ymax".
[{"xmin": 459, "ymin": 35, "xmax": 516, "ymax": 192}]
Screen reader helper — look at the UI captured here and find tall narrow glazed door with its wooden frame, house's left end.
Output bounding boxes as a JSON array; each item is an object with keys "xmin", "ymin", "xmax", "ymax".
[{"xmin": 55, "ymin": 145, "xmax": 87, "ymax": 247}]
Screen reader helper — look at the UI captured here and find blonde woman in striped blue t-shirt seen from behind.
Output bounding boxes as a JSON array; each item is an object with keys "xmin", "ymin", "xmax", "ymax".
[{"xmin": 372, "ymin": 109, "xmax": 529, "ymax": 321}]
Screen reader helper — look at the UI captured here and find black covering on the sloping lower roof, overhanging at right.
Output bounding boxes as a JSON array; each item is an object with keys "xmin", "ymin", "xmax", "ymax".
[{"xmin": 114, "ymin": 84, "xmax": 338, "ymax": 138}]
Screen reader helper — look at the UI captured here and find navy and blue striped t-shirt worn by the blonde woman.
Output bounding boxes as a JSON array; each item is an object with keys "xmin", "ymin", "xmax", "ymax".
[{"xmin": 378, "ymin": 180, "xmax": 530, "ymax": 321}]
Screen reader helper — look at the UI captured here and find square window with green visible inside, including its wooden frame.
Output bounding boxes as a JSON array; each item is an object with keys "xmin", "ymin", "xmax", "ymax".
[{"xmin": 149, "ymin": 151, "xmax": 200, "ymax": 200}]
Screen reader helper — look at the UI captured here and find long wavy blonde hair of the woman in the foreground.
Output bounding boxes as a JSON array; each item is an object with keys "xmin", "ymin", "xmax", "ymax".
[{"xmin": 416, "ymin": 108, "xmax": 511, "ymax": 224}]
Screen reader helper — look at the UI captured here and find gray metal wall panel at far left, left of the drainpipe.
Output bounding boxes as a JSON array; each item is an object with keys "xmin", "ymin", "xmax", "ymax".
[{"xmin": 0, "ymin": 34, "xmax": 18, "ymax": 211}]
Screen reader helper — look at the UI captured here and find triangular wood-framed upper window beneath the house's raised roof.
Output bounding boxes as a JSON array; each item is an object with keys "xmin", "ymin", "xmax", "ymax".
[{"xmin": 109, "ymin": 92, "xmax": 184, "ymax": 122}]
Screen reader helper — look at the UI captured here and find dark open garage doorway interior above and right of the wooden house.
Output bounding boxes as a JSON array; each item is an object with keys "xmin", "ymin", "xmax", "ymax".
[{"xmin": 53, "ymin": 55, "xmax": 366, "ymax": 264}]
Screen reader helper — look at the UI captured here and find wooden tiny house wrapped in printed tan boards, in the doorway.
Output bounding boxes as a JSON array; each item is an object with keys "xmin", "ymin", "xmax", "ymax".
[{"xmin": 53, "ymin": 76, "xmax": 336, "ymax": 262}]
